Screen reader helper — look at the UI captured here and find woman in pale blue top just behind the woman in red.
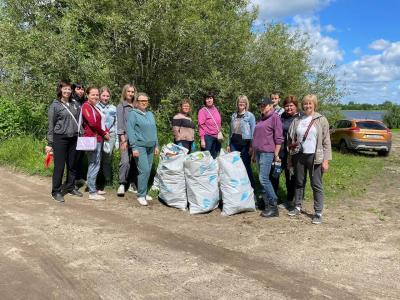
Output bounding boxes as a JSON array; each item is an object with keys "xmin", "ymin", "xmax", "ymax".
[{"xmin": 96, "ymin": 87, "xmax": 117, "ymax": 192}]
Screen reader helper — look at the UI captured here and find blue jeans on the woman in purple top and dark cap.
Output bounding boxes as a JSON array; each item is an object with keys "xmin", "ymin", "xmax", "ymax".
[{"xmin": 256, "ymin": 151, "xmax": 278, "ymax": 206}]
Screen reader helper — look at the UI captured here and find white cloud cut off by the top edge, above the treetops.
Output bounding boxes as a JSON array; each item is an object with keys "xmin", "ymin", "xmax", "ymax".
[{"xmin": 250, "ymin": 0, "xmax": 332, "ymax": 22}]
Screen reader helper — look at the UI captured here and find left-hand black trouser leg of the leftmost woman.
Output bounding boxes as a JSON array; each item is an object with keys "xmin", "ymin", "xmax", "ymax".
[{"xmin": 51, "ymin": 134, "xmax": 68, "ymax": 195}]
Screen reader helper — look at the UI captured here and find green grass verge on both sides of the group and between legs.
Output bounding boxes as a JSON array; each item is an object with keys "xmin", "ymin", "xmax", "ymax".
[{"xmin": 0, "ymin": 137, "xmax": 391, "ymax": 205}]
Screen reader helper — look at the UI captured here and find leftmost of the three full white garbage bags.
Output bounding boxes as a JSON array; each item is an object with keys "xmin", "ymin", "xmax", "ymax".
[{"xmin": 154, "ymin": 143, "xmax": 188, "ymax": 210}]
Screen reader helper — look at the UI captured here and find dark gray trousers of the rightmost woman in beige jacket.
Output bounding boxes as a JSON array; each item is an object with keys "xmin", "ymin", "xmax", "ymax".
[{"xmin": 293, "ymin": 153, "xmax": 324, "ymax": 214}]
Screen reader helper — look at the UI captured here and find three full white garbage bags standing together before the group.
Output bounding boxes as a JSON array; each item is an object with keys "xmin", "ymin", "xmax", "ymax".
[{"xmin": 153, "ymin": 143, "xmax": 255, "ymax": 216}]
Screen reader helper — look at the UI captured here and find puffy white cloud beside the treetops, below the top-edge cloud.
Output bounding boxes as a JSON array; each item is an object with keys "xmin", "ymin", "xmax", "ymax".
[{"xmin": 293, "ymin": 16, "xmax": 343, "ymax": 66}]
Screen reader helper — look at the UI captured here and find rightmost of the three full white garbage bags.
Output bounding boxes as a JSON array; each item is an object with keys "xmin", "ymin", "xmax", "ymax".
[{"xmin": 218, "ymin": 151, "xmax": 256, "ymax": 216}]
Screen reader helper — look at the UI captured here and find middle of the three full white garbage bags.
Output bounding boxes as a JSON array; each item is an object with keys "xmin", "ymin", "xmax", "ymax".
[{"xmin": 184, "ymin": 151, "xmax": 219, "ymax": 214}]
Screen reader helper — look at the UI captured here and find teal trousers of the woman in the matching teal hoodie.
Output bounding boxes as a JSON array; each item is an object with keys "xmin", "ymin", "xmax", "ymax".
[{"xmin": 135, "ymin": 147, "xmax": 155, "ymax": 197}]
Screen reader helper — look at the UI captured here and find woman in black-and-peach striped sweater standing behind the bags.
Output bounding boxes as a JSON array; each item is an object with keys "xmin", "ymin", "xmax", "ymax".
[{"xmin": 172, "ymin": 99, "xmax": 195, "ymax": 153}]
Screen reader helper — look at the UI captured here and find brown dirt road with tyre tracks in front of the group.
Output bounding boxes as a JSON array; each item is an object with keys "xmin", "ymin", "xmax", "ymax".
[{"xmin": 0, "ymin": 136, "xmax": 400, "ymax": 299}]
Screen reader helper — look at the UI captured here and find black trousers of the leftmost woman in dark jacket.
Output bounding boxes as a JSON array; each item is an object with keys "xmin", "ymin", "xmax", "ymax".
[{"xmin": 51, "ymin": 134, "xmax": 78, "ymax": 195}]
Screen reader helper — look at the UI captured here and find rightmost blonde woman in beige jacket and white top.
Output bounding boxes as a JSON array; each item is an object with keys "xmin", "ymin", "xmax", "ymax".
[{"xmin": 288, "ymin": 95, "xmax": 332, "ymax": 224}]
